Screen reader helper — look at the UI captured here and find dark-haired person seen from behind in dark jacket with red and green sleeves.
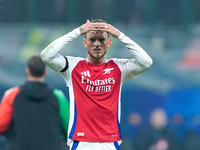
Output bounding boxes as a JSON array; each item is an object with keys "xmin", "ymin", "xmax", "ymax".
[{"xmin": 0, "ymin": 55, "xmax": 69, "ymax": 150}]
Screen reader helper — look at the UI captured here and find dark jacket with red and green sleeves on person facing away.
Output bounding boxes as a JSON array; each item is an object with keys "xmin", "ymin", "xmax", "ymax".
[{"xmin": 0, "ymin": 81, "xmax": 69, "ymax": 150}]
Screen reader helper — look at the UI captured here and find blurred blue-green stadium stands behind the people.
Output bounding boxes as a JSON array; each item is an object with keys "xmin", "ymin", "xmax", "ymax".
[{"xmin": 0, "ymin": 0, "xmax": 200, "ymax": 150}]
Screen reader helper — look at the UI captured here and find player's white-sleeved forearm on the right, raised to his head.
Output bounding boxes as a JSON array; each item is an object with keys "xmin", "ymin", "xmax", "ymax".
[{"xmin": 118, "ymin": 33, "xmax": 153, "ymax": 69}]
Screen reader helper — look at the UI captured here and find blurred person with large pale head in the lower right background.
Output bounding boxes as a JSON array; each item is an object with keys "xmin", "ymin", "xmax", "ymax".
[{"xmin": 134, "ymin": 108, "xmax": 180, "ymax": 150}]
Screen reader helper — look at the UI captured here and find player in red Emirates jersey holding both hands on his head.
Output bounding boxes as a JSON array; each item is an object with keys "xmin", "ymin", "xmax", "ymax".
[{"xmin": 41, "ymin": 19, "xmax": 152, "ymax": 150}]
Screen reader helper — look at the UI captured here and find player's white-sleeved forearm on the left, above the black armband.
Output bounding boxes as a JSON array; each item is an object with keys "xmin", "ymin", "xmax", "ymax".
[{"xmin": 41, "ymin": 28, "xmax": 81, "ymax": 67}]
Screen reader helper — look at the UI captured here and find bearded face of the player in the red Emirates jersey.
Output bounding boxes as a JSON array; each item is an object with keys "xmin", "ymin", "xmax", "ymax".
[{"xmin": 83, "ymin": 31, "xmax": 111, "ymax": 60}]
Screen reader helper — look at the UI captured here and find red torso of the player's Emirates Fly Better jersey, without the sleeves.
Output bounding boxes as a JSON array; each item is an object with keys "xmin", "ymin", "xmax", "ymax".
[{"xmin": 62, "ymin": 56, "xmax": 122, "ymax": 142}]
